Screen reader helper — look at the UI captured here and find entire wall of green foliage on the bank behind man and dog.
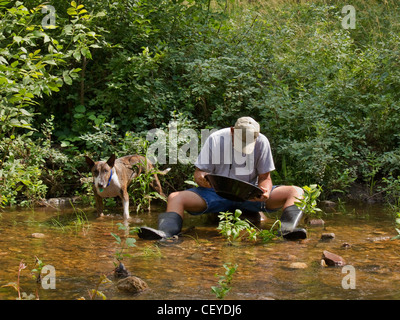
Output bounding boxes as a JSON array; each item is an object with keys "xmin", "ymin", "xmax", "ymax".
[{"xmin": 0, "ymin": 0, "xmax": 400, "ymax": 206}]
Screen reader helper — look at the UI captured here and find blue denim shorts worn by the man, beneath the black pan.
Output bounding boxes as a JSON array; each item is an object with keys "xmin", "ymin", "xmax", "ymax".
[{"xmin": 186, "ymin": 186, "xmax": 279, "ymax": 215}]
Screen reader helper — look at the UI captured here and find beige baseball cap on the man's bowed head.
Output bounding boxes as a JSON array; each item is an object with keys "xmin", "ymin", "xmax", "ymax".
[{"xmin": 233, "ymin": 117, "xmax": 260, "ymax": 154}]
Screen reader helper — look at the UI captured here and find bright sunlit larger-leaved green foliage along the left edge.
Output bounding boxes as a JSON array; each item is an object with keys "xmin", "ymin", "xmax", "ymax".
[{"xmin": 0, "ymin": 1, "xmax": 106, "ymax": 205}]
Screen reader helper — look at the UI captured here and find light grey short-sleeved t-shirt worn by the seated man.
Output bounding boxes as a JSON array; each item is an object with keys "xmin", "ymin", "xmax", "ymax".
[{"xmin": 195, "ymin": 128, "xmax": 275, "ymax": 184}]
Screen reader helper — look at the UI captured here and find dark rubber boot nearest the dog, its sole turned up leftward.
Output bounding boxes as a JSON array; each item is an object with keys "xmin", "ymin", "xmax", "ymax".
[{"xmin": 138, "ymin": 211, "xmax": 183, "ymax": 240}]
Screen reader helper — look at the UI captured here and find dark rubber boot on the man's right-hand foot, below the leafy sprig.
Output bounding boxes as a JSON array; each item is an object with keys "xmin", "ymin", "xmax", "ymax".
[{"xmin": 280, "ymin": 205, "xmax": 307, "ymax": 240}]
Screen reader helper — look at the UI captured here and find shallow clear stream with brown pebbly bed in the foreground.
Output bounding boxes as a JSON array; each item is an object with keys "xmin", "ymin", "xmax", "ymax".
[{"xmin": 0, "ymin": 205, "xmax": 400, "ymax": 300}]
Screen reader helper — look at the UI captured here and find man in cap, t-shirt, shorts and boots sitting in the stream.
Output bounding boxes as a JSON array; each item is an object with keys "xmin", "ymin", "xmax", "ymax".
[{"xmin": 138, "ymin": 117, "xmax": 307, "ymax": 240}]
